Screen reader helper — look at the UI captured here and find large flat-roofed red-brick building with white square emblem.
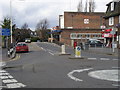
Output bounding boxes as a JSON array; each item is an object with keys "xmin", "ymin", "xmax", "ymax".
[{"xmin": 59, "ymin": 12, "xmax": 104, "ymax": 46}]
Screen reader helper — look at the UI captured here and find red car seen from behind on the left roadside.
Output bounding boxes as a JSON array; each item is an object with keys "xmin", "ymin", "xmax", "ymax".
[{"xmin": 16, "ymin": 43, "xmax": 29, "ymax": 52}]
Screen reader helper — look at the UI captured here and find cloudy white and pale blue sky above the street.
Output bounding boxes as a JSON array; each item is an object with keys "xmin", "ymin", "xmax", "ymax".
[{"xmin": 0, "ymin": 0, "xmax": 111, "ymax": 31}]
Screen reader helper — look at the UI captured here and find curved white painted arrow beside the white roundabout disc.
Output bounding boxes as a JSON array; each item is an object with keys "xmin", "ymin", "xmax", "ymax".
[{"xmin": 67, "ymin": 68, "xmax": 93, "ymax": 81}]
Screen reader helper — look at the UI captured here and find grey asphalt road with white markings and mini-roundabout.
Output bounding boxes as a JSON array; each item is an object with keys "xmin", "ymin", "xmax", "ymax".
[{"xmin": 1, "ymin": 42, "xmax": 120, "ymax": 88}]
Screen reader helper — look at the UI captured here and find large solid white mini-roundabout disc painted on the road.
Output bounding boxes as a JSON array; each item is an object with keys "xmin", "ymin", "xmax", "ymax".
[{"xmin": 88, "ymin": 70, "xmax": 120, "ymax": 82}]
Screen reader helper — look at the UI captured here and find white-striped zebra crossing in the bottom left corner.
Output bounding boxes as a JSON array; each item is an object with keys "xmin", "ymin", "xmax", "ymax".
[{"xmin": 0, "ymin": 70, "xmax": 26, "ymax": 88}]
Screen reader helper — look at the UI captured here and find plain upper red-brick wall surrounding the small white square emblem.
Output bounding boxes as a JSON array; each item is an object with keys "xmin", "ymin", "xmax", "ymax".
[{"xmin": 64, "ymin": 12, "xmax": 104, "ymax": 28}]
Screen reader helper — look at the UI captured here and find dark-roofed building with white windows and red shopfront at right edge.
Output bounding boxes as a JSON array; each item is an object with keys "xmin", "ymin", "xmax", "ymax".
[{"xmin": 104, "ymin": 0, "xmax": 120, "ymax": 48}]
